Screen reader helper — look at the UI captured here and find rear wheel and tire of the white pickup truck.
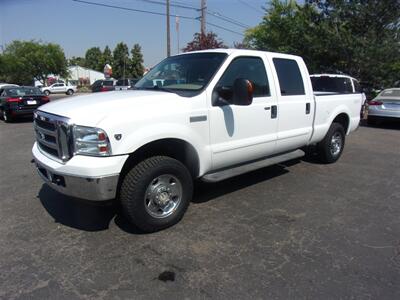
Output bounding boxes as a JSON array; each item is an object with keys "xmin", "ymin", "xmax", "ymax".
[{"xmin": 318, "ymin": 123, "xmax": 346, "ymax": 164}]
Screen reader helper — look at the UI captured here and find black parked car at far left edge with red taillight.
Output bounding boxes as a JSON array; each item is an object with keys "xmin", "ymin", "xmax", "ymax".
[{"xmin": 0, "ymin": 86, "xmax": 50, "ymax": 122}]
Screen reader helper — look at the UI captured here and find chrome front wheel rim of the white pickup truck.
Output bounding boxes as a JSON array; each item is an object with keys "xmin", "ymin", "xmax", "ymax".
[{"xmin": 144, "ymin": 174, "xmax": 183, "ymax": 218}]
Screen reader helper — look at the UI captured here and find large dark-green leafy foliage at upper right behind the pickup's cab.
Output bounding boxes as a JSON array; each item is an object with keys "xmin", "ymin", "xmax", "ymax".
[{"xmin": 245, "ymin": 0, "xmax": 400, "ymax": 87}]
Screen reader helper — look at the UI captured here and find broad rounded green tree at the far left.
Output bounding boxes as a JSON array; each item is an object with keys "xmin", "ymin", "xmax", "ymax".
[{"xmin": 1, "ymin": 41, "xmax": 68, "ymax": 85}]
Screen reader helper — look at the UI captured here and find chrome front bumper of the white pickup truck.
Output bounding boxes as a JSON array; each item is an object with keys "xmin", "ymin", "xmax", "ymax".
[{"xmin": 36, "ymin": 162, "xmax": 119, "ymax": 201}]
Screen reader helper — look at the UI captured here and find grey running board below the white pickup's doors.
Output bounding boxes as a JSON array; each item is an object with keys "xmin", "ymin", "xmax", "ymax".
[{"xmin": 201, "ymin": 150, "xmax": 305, "ymax": 182}]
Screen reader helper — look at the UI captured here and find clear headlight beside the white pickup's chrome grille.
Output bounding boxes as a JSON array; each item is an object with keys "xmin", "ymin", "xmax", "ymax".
[{"xmin": 73, "ymin": 125, "xmax": 111, "ymax": 156}]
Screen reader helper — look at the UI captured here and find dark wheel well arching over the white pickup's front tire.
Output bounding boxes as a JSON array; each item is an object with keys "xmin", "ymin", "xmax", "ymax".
[{"xmin": 120, "ymin": 138, "xmax": 200, "ymax": 178}]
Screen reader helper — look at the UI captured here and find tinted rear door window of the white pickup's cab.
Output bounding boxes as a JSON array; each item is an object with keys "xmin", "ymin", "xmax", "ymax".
[{"xmin": 272, "ymin": 58, "xmax": 305, "ymax": 96}]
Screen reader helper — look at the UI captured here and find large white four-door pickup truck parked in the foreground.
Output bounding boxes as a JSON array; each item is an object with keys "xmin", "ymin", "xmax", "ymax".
[{"xmin": 32, "ymin": 49, "xmax": 362, "ymax": 232}]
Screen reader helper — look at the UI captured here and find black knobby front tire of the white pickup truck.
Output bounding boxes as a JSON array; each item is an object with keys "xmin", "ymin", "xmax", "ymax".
[{"xmin": 119, "ymin": 156, "xmax": 193, "ymax": 232}]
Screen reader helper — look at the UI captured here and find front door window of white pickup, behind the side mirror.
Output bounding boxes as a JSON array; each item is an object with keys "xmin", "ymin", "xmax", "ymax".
[{"xmin": 216, "ymin": 57, "xmax": 270, "ymax": 100}]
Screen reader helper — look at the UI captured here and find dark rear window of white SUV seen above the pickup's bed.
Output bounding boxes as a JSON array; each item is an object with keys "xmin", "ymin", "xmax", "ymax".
[{"xmin": 311, "ymin": 76, "xmax": 353, "ymax": 94}]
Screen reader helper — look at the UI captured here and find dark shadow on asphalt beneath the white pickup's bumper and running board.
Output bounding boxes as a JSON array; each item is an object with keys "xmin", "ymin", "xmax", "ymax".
[{"xmin": 38, "ymin": 160, "xmax": 300, "ymax": 234}]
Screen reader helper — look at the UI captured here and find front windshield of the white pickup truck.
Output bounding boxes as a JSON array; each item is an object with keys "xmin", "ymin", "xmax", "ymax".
[{"xmin": 135, "ymin": 53, "xmax": 227, "ymax": 92}]
